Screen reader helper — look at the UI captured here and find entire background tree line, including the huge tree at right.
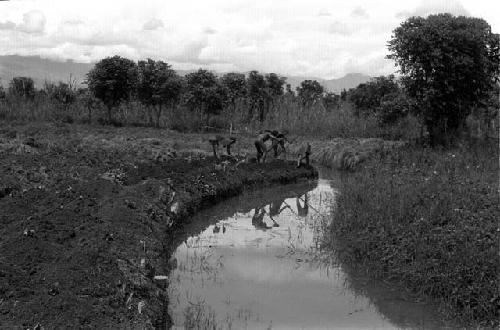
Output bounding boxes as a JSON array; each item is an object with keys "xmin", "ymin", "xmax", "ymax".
[{"xmin": 0, "ymin": 14, "xmax": 500, "ymax": 145}]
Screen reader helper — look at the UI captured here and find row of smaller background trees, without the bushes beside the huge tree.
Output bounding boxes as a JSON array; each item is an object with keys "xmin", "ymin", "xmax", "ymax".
[{"xmin": 0, "ymin": 56, "xmax": 340, "ymax": 125}]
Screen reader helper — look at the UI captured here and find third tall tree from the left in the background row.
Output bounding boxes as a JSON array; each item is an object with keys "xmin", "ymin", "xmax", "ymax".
[{"xmin": 185, "ymin": 69, "xmax": 225, "ymax": 125}]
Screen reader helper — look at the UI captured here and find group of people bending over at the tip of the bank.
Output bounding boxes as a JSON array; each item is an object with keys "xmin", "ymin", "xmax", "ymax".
[{"xmin": 209, "ymin": 130, "xmax": 311, "ymax": 167}]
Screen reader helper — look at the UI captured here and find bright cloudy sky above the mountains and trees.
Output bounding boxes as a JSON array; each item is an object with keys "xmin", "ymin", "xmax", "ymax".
[{"xmin": 0, "ymin": 0, "xmax": 500, "ymax": 79}]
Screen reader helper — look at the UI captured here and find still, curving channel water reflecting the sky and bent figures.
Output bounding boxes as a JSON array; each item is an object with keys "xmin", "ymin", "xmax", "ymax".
[{"xmin": 168, "ymin": 173, "xmax": 450, "ymax": 329}]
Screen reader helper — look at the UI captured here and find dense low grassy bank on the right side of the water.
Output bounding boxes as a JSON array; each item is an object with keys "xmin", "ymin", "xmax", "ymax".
[{"xmin": 327, "ymin": 142, "xmax": 500, "ymax": 325}]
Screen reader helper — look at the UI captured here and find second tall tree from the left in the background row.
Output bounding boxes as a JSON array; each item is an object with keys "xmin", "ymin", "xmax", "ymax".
[{"xmin": 137, "ymin": 59, "xmax": 183, "ymax": 126}]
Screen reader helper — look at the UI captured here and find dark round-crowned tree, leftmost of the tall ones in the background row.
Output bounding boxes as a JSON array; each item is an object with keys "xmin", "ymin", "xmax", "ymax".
[{"xmin": 87, "ymin": 56, "xmax": 137, "ymax": 121}]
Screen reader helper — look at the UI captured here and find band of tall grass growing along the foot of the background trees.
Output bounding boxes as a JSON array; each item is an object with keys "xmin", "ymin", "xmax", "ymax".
[{"xmin": 0, "ymin": 94, "xmax": 419, "ymax": 139}]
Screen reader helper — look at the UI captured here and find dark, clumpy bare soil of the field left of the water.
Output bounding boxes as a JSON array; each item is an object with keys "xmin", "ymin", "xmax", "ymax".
[{"xmin": 0, "ymin": 124, "xmax": 317, "ymax": 329}]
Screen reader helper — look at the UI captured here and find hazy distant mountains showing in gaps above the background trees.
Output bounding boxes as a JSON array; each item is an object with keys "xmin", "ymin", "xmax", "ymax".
[{"xmin": 0, "ymin": 55, "xmax": 371, "ymax": 93}]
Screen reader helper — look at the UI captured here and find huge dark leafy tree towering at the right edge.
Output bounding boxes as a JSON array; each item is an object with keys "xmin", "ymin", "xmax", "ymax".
[{"xmin": 388, "ymin": 14, "xmax": 499, "ymax": 144}]
